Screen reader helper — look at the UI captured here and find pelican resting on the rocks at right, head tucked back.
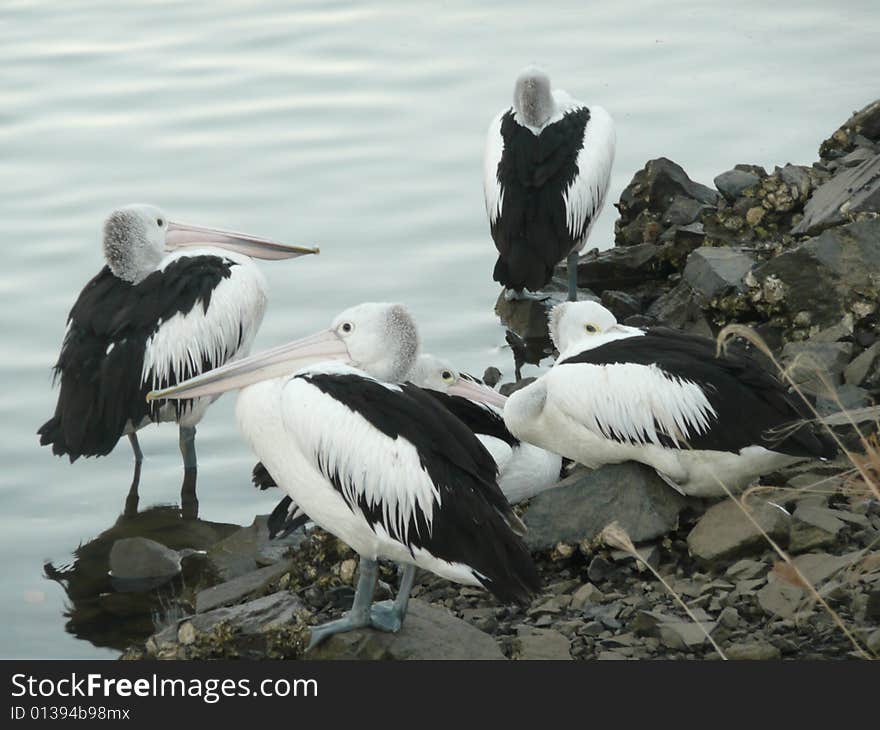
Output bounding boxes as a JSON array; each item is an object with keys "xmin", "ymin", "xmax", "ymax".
[{"xmin": 504, "ymin": 301, "xmax": 835, "ymax": 497}]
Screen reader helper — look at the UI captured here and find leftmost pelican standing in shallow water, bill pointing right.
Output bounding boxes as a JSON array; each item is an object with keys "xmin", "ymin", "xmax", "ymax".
[{"xmin": 38, "ymin": 205, "xmax": 318, "ymax": 512}]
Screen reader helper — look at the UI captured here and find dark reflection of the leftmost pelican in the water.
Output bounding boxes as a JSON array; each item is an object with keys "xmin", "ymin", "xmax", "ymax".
[{"xmin": 43, "ymin": 500, "xmax": 239, "ymax": 650}]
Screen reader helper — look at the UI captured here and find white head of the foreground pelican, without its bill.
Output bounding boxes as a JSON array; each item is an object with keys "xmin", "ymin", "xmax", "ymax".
[{"xmin": 331, "ymin": 302, "xmax": 419, "ymax": 383}]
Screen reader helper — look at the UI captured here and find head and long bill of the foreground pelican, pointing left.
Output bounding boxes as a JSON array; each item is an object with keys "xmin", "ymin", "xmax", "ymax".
[{"xmin": 147, "ymin": 302, "xmax": 419, "ymax": 401}]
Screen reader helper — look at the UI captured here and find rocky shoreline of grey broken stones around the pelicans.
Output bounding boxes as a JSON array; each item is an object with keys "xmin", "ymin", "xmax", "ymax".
[{"xmin": 123, "ymin": 100, "xmax": 880, "ymax": 659}]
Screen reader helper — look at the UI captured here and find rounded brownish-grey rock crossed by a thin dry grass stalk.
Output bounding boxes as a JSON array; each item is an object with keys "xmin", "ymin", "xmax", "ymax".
[{"xmin": 687, "ymin": 499, "xmax": 790, "ymax": 564}]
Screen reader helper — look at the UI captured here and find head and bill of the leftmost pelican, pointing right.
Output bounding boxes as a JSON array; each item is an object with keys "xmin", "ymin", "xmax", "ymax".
[{"xmin": 103, "ymin": 203, "xmax": 319, "ymax": 284}]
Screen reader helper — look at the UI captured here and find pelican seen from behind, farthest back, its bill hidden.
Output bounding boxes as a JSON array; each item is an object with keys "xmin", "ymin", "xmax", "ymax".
[{"xmin": 483, "ymin": 67, "xmax": 615, "ymax": 301}]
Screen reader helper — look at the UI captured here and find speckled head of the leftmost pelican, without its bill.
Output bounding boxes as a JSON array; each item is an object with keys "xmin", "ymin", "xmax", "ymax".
[{"xmin": 103, "ymin": 204, "xmax": 168, "ymax": 284}]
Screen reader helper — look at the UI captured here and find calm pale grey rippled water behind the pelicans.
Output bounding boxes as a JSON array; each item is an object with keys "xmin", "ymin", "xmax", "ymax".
[{"xmin": 0, "ymin": 0, "xmax": 880, "ymax": 657}]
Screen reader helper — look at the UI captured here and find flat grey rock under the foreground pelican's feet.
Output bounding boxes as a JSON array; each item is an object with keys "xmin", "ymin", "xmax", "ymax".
[{"xmin": 307, "ymin": 598, "xmax": 504, "ymax": 660}]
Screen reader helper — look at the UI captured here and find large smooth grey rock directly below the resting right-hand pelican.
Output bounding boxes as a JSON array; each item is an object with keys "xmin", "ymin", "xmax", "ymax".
[{"xmin": 523, "ymin": 462, "xmax": 687, "ymax": 550}]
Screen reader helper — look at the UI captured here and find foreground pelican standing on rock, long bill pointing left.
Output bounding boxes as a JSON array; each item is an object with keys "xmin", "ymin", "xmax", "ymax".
[{"xmin": 149, "ymin": 303, "xmax": 539, "ymax": 645}]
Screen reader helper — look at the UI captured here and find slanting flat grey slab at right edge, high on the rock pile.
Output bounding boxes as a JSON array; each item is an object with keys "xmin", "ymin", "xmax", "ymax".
[{"xmin": 792, "ymin": 155, "xmax": 880, "ymax": 235}]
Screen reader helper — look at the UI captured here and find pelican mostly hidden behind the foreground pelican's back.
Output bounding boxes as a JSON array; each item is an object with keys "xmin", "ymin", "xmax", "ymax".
[{"xmin": 253, "ymin": 354, "xmax": 562, "ymax": 537}]
